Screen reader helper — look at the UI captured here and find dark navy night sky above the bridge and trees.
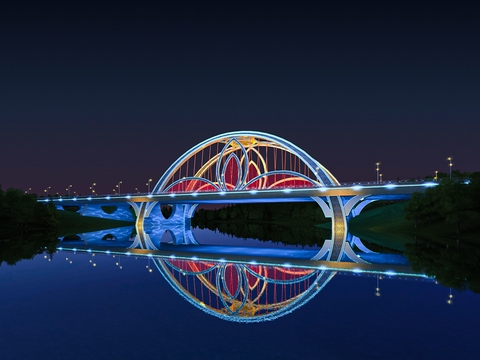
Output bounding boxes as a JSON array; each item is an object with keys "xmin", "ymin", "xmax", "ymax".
[{"xmin": 0, "ymin": 1, "xmax": 480, "ymax": 194}]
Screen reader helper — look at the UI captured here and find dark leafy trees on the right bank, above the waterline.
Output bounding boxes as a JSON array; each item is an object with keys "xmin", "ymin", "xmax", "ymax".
[{"xmin": 404, "ymin": 172, "xmax": 480, "ymax": 234}]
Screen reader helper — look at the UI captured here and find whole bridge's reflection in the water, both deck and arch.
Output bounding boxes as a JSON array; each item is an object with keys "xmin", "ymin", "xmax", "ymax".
[{"xmin": 59, "ymin": 227, "xmax": 434, "ymax": 322}]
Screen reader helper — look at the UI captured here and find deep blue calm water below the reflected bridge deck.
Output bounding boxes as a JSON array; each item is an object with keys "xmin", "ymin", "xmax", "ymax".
[{"xmin": 0, "ymin": 231, "xmax": 480, "ymax": 359}]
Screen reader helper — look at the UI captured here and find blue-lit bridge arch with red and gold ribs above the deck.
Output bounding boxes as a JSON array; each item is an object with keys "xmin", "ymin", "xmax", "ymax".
[{"xmin": 153, "ymin": 131, "xmax": 339, "ymax": 194}]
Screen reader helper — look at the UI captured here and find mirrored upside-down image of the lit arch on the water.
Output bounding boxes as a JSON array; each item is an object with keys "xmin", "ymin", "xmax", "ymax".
[{"xmin": 154, "ymin": 259, "xmax": 335, "ymax": 323}]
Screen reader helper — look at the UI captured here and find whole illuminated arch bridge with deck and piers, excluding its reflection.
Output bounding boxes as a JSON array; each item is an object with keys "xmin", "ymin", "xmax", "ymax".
[{"xmin": 47, "ymin": 131, "xmax": 436, "ymax": 262}]
